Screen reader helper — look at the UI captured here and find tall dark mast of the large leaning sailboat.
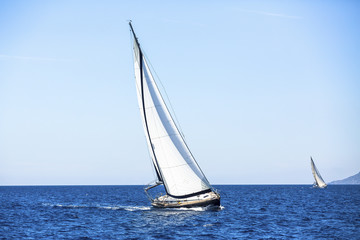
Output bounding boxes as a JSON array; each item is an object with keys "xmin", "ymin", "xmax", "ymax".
[{"xmin": 129, "ymin": 20, "xmax": 162, "ymax": 182}]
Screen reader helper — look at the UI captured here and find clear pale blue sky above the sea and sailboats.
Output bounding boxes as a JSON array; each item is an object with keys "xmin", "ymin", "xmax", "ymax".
[{"xmin": 0, "ymin": 0, "xmax": 360, "ymax": 185}]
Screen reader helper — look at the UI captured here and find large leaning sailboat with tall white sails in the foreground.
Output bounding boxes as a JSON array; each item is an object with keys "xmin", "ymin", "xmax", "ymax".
[{"xmin": 129, "ymin": 21, "xmax": 220, "ymax": 208}]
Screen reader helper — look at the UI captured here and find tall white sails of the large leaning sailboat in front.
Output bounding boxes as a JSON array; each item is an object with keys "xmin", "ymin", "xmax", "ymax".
[{"xmin": 134, "ymin": 28, "xmax": 211, "ymax": 198}]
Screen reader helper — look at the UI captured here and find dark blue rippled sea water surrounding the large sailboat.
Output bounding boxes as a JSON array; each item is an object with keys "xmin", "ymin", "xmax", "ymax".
[{"xmin": 0, "ymin": 185, "xmax": 360, "ymax": 239}]
